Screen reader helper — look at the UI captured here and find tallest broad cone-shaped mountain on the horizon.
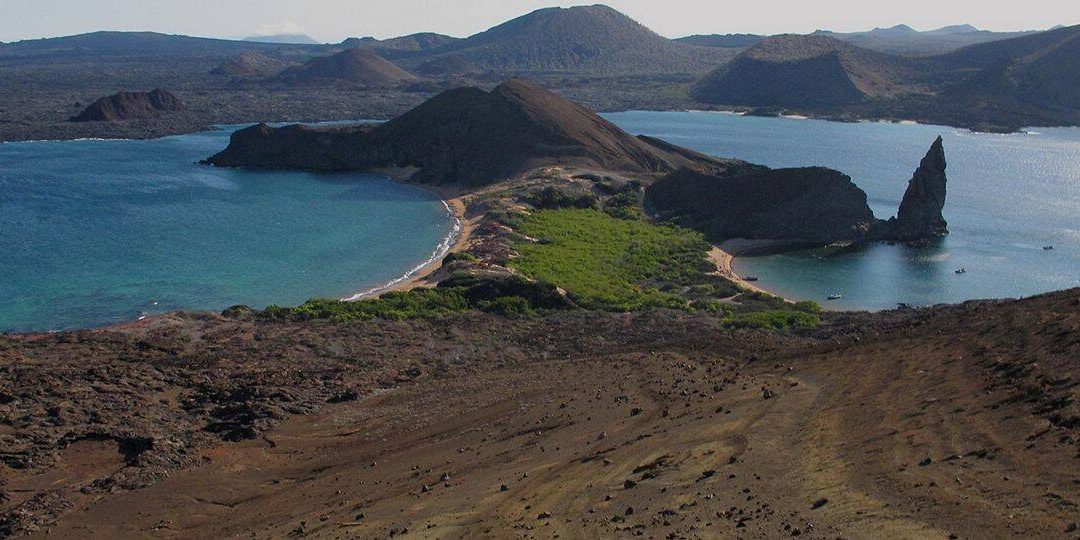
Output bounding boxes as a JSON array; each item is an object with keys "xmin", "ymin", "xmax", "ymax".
[{"xmin": 406, "ymin": 5, "xmax": 731, "ymax": 75}]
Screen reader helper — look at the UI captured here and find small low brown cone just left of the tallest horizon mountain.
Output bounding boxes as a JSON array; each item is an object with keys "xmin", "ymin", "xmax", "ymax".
[{"xmin": 275, "ymin": 49, "xmax": 417, "ymax": 86}]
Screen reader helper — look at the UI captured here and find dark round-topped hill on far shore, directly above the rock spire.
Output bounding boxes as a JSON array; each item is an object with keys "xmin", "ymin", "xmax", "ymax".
[{"xmin": 691, "ymin": 36, "xmax": 913, "ymax": 107}]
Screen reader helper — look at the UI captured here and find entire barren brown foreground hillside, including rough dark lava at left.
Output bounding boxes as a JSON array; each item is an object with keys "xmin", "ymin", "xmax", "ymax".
[{"xmin": 0, "ymin": 289, "xmax": 1080, "ymax": 538}]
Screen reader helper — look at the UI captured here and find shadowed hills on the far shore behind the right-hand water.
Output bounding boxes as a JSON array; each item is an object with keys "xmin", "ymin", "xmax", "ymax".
[{"xmin": 691, "ymin": 25, "xmax": 1080, "ymax": 131}]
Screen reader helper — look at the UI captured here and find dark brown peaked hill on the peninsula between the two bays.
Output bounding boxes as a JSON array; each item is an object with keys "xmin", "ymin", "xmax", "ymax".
[{"xmin": 207, "ymin": 80, "xmax": 723, "ymax": 186}]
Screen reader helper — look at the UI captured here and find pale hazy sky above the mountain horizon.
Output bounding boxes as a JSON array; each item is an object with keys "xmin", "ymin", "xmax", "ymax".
[{"xmin": 0, "ymin": 0, "xmax": 1080, "ymax": 42}]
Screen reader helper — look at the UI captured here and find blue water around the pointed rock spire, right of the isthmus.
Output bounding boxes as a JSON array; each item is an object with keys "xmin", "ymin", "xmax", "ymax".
[{"xmin": 606, "ymin": 112, "xmax": 1080, "ymax": 310}]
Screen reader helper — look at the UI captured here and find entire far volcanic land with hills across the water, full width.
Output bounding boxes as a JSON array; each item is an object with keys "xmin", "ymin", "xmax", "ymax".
[{"xmin": 0, "ymin": 5, "xmax": 1080, "ymax": 140}]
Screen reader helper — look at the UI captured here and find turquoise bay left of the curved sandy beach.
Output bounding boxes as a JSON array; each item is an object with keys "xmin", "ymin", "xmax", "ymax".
[{"xmin": 0, "ymin": 131, "xmax": 454, "ymax": 332}]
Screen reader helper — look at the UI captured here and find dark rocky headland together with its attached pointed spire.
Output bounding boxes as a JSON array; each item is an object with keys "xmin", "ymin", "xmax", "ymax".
[{"xmin": 645, "ymin": 137, "xmax": 947, "ymax": 244}]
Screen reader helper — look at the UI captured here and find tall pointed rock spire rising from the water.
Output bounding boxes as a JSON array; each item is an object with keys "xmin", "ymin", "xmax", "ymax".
[{"xmin": 874, "ymin": 137, "xmax": 948, "ymax": 242}]
